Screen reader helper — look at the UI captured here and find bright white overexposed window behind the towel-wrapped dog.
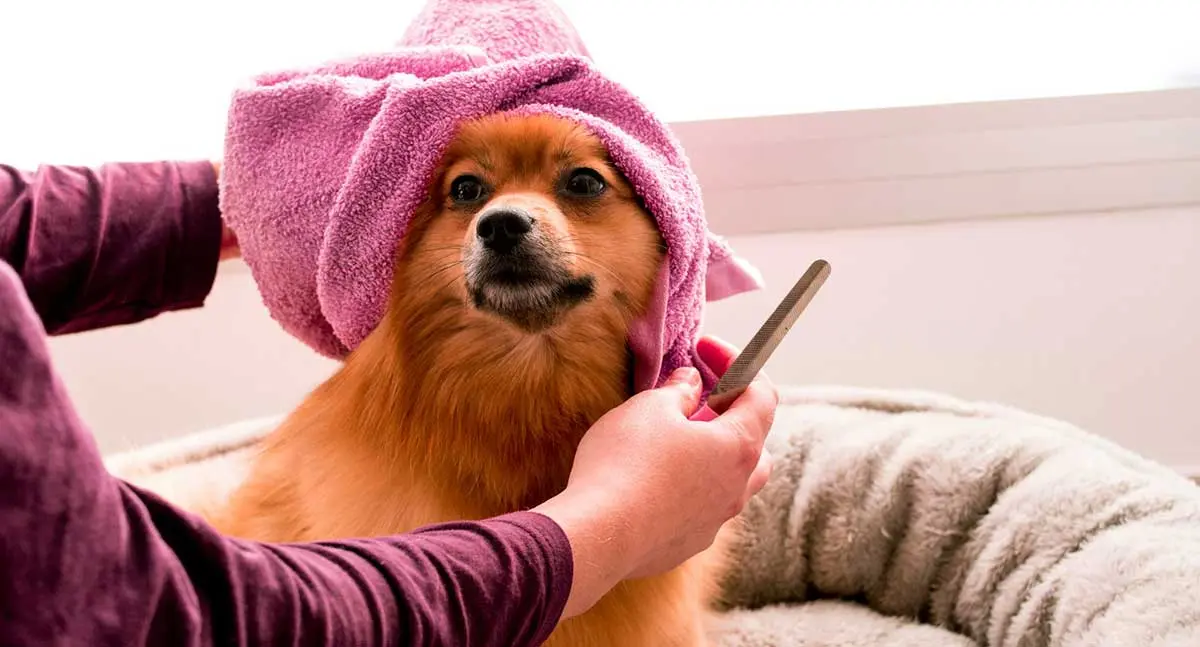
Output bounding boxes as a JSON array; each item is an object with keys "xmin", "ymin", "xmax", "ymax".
[{"xmin": 0, "ymin": 0, "xmax": 1200, "ymax": 166}]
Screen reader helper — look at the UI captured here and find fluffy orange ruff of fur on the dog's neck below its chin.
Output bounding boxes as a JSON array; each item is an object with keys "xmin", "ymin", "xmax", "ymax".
[{"xmin": 320, "ymin": 288, "xmax": 629, "ymax": 515}]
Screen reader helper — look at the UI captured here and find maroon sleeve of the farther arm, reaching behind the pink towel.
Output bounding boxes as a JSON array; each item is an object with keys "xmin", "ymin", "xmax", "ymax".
[{"xmin": 0, "ymin": 162, "xmax": 221, "ymax": 335}]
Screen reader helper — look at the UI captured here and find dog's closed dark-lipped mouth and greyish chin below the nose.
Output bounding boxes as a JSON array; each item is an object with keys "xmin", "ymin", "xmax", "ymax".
[{"xmin": 467, "ymin": 253, "xmax": 595, "ymax": 333}]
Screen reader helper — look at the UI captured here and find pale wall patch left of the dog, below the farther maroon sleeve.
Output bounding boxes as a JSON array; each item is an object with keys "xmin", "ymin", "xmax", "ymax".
[{"xmin": 50, "ymin": 263, "xmax": 335, "ymax": 453}]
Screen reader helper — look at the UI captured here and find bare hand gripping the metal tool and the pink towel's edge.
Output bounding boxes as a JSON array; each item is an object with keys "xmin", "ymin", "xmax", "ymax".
[{"xmin": 535, "ymin": 339, "xmax": 779, "ymax": 617}]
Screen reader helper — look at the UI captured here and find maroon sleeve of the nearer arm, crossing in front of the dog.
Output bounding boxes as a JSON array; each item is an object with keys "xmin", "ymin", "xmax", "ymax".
[{"xmin": 0, "ymin": 262, "xmax": 574, "ymax": 647}]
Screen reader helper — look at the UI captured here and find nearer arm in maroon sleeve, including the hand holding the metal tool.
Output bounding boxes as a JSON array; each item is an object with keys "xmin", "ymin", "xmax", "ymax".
[{"xmin": 0, "ymin": 226, "xmax": 776, "ymax": 647}]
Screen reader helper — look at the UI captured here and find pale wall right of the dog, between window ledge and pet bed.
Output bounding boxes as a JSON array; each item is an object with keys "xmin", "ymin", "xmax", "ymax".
[{"xmin": 707, "ymin": 206, "xmax": 1200, "ymax": 473}]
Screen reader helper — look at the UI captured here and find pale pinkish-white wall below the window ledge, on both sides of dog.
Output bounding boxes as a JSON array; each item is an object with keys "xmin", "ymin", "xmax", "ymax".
[{"xmin": 53, "ymin": 209, "xmax": 1200, "ymax": 468}]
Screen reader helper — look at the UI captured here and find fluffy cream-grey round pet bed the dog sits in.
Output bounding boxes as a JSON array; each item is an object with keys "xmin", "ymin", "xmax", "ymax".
[{"xmin": 108, "ymin": 388, "xmax": 1200, "ymax": 647}]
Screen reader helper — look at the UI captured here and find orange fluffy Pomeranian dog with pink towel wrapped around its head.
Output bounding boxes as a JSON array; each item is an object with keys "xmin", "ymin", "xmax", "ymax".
[{"xmin": 217, "ymin": 115, "xmax": 720, "ymax": 647}]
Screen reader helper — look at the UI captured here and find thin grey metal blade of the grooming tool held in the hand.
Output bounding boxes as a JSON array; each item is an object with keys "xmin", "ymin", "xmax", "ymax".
[{"xmin": 708, "ymin": 260, "xmax": 830, "ymax": 411}]
